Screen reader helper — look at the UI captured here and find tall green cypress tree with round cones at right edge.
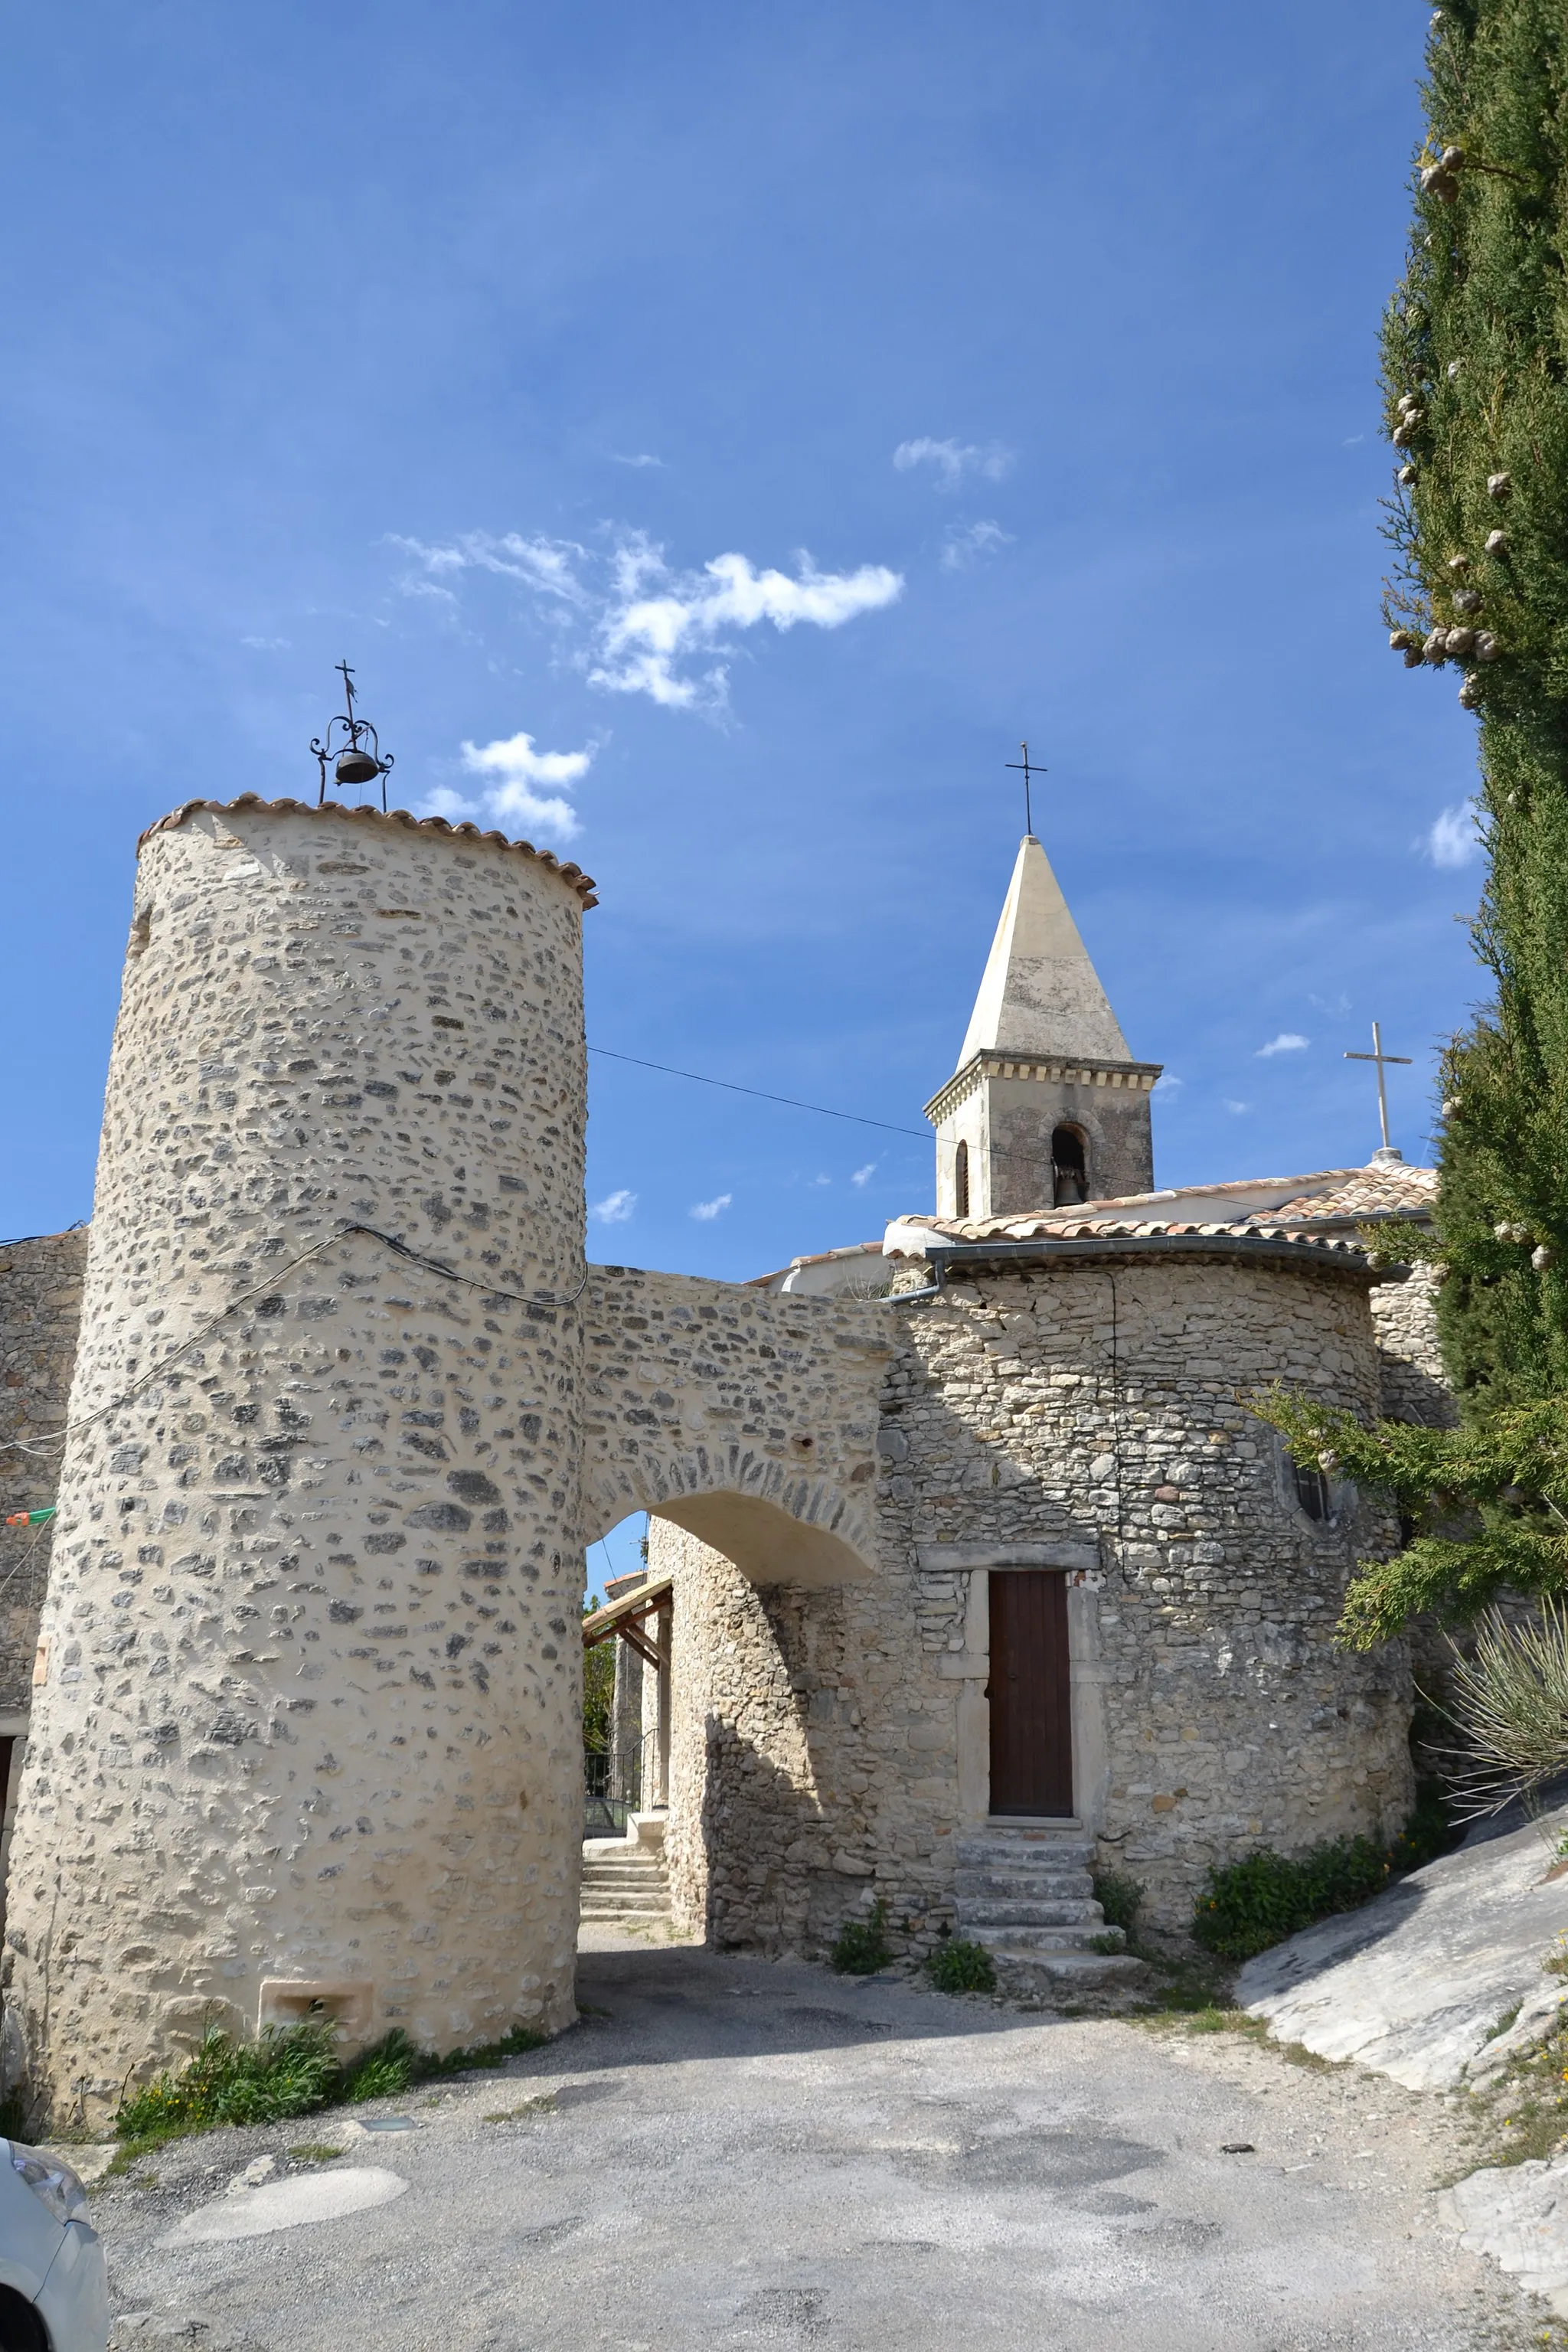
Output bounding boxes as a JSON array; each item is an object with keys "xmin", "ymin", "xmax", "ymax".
[{"xmin": 1258, "ymin": 0, "xmax": 1568, "ymax": 1648}]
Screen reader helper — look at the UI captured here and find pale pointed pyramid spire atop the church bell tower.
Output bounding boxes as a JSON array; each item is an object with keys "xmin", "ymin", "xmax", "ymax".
[{"xmin": 959, "ymin": 832, "xmax": 1133, "ymax": 1070}]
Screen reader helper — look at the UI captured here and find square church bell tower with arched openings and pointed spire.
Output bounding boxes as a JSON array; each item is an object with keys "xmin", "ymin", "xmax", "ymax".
[{"xmin": 926, "ymin": 832, "xmax": 1161, "ymax": 1218}]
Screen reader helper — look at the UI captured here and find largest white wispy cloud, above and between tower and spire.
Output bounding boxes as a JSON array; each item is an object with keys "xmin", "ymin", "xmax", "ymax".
[{"xmin": 393, "ymin": 531, "xmax": 903, "ymax": 710}]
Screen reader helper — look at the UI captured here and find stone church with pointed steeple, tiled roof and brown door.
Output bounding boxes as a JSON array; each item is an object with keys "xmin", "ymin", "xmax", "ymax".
[{"xmin": 628, "ymin": 840, "xmax": 1448, "ymax": 1981}]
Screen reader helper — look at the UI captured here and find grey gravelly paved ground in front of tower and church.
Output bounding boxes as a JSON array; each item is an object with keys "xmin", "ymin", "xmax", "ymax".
[{"xmin": 94, "ymin": 1933, "xmax": 1561, "ymax": 2352}]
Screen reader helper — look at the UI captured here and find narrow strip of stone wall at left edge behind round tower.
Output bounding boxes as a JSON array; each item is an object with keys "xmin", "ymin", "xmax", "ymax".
[{"xmin": 0, "ymin": 1228, "xmax": 87, "ymax": 1722}]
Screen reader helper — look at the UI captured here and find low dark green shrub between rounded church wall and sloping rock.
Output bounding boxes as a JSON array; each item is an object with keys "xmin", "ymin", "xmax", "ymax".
[{"xmin": 1192, "ymin": 1790, "xmax": 1455, "ymax": 1962}]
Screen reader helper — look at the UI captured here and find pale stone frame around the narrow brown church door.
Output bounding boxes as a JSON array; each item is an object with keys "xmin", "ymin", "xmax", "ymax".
[{"xmin": 920, "ymin": 1540, "xmax": 1109, "ymax": 1832}]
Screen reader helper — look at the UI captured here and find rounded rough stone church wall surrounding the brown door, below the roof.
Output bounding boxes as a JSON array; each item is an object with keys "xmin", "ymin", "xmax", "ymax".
[{"xmin": 652, "ymin": 1251, "xmax": 1413, "ymax": 1950}]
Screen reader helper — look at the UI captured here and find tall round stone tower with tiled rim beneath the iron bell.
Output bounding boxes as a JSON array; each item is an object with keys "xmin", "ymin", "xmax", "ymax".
[{"xmin": 7, "ymin": 795, "xmax": 595, "ymax": 2126}]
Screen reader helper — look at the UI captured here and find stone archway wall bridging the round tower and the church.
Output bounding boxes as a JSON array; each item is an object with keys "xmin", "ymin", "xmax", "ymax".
[{"xmin": 583, "ymin": 1266, "xmax": 893, "ymax": 1586}]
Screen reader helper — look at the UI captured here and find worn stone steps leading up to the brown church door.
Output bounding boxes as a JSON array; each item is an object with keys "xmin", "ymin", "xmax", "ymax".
[{"xmin": 955, "ymin": 1821, "xmax": 1145, "ymax": 1999}]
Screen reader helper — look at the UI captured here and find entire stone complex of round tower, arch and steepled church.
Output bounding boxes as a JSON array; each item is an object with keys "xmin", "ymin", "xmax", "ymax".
[{"xmin": 0, "ymin": 795, "xmax": 1446, "ymax": 2122}]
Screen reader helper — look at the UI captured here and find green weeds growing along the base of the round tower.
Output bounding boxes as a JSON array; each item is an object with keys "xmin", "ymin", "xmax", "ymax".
[{"xmin": 115, "ymin": 2020, "xmax": 547, "ymax": 2152}]
